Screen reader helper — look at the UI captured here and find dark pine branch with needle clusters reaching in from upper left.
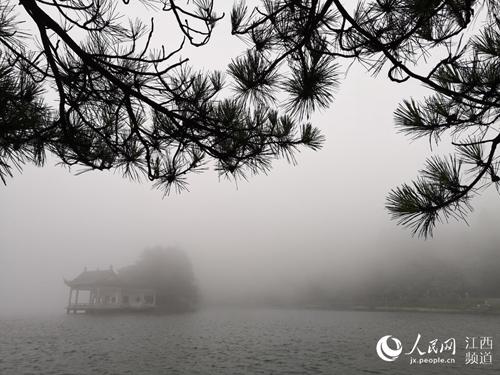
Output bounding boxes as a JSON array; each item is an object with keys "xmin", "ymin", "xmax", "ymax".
[{"xmin": 0, "ymin": 0, "xmax": 322, "ymax": 192}]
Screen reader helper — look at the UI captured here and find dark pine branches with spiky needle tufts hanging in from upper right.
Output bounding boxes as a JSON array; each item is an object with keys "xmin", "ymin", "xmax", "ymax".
[{"xmin": 230, "ymin": 0, "xmax": 500, "ymax": 236}]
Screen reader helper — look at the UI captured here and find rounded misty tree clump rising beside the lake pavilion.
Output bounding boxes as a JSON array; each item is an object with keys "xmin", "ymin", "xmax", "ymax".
[{"xmin": 118, "ymin": 247, "xmax": 200, "ymax": 311}]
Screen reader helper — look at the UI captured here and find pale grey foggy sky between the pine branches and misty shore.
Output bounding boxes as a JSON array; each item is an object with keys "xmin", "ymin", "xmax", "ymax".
[{"xmin": 0, "ymin": 1, "xmax": 500, "ymax": 313}]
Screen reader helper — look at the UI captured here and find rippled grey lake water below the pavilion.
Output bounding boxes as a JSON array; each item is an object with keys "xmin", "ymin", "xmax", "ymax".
[{"xmin": 0, "ymin": 309, "xmax": 500, "ymax": 375}]
